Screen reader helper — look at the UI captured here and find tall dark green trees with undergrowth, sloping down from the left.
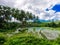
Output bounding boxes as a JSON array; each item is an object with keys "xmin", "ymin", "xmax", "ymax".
[{"xmin": 0, "ymin": 5, "xmax": 37, "ymax": 29}]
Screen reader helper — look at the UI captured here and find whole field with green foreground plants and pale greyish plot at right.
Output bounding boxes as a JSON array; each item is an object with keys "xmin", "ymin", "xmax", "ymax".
[{"xmin": 0, "ymin": 27, "xmax": 60, "ymax": 45}]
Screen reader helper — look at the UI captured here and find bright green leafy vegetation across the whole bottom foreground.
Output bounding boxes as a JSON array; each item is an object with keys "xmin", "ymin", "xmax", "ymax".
[{"xmin": 0, "ymin": 32, "xmax": 60, "ymax": 45}]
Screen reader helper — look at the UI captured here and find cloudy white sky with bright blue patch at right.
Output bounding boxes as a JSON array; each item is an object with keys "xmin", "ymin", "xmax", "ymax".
[{"xmin": 0, "ymin": 0, "xmax": 60, "ymax": 20}]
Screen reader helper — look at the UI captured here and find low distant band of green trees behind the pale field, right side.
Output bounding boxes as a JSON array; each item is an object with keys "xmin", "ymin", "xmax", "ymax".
[{"xmin": 28, "ymin": 22, "xmax": 60, "ymax": 28}]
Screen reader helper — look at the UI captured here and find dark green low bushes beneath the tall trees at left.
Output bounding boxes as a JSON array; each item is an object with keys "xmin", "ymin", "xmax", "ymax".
[{"xmin": 0, "ymin": 22, "xmax": 20, "ymax": 30}]
